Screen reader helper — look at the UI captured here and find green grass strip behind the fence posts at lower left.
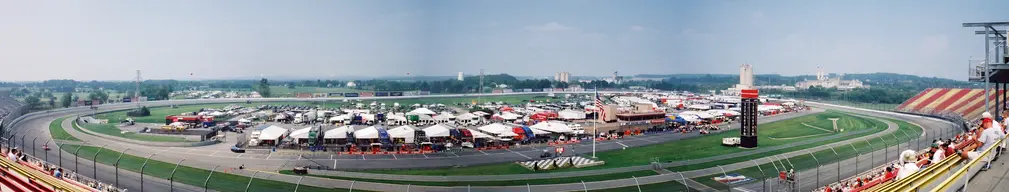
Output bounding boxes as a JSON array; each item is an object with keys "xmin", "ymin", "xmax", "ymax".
[{"xmin": 63, "ymin": 145, "xmax": 367, "ymax": 192}]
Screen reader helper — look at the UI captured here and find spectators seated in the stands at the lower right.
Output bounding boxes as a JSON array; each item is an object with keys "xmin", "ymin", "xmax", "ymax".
[{"xmin": 813, "ymin": 111, "xmax": 1009, "ymax": 192}]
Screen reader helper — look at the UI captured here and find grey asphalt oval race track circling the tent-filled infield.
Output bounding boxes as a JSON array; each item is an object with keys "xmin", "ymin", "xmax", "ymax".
[{"xmin": 0, "ymin": 95, "xmax": 951, "ymax": 191}]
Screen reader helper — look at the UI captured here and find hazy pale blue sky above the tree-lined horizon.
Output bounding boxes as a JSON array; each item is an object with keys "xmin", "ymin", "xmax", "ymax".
[{"xmin": 0, "ymin": 0, "xmax": 1009, "ymax": 81}]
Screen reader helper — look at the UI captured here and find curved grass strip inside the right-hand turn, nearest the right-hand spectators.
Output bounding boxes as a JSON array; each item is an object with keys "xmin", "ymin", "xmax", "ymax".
[{"xmin": 693, "ymin": 118, "xmax": 922, "ymax": 190}]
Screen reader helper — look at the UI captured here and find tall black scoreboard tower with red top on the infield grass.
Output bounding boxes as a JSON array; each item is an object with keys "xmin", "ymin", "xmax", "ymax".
[{"xmin": 740, "ymin": 89, "xmax": 760, "ymax": 148}]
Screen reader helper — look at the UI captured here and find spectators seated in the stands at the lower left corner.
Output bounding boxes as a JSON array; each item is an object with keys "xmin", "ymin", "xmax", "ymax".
[{"xmin": 0, "ymin": 147, "xmax": 125, "ymax": 192}]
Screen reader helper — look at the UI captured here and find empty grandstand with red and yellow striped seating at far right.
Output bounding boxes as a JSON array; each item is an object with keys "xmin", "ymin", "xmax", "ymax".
[{"xmin": 895, "ymin": 88, "xmax": 1006, "ymax": 119}]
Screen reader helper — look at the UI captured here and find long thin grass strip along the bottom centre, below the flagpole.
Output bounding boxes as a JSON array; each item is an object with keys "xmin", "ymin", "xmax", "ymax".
[{"xmin": 281, "ymin": 170, "xmax": 658, "ymax": 186}]
